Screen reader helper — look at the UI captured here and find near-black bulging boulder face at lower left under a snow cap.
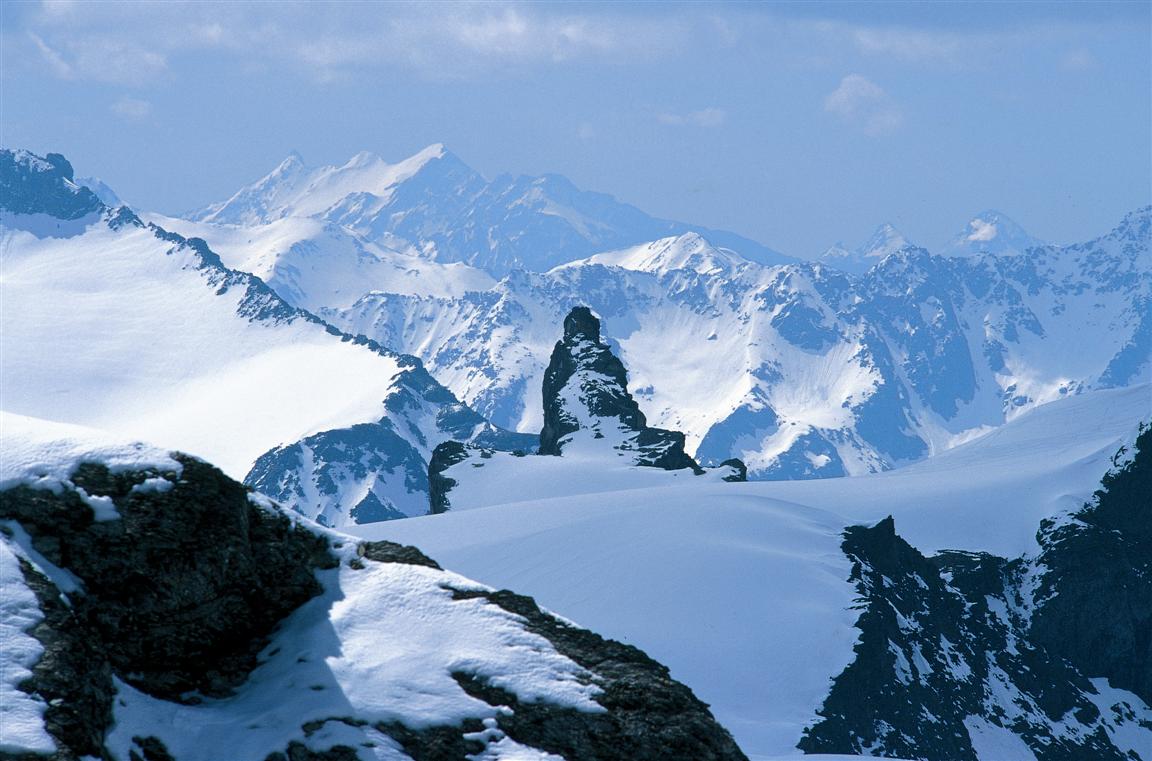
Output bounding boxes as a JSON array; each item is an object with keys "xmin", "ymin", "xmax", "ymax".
[{"xmin": 0, "ymin": 456, "xmax": 333, "ymax": 699}]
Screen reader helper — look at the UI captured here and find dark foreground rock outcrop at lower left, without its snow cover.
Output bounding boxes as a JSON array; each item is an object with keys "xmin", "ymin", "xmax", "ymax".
[{"xmin": 0, "ymin": 455, "xmax": 744, "ymax": 761}]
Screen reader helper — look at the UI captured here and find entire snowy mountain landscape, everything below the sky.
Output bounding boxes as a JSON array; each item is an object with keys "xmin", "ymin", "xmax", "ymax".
[{"xmin": 0, "ymin": 146, "xmax": 1152, "ymax": 761}]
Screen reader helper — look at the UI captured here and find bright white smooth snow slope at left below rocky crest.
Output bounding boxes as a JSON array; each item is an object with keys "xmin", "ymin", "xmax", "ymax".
[{"xmin": 0, "ymin": 216, "xmax": 400, "ymax": 479}]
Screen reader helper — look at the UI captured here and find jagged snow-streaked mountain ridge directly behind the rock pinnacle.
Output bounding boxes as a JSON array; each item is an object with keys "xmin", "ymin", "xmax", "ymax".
[{"xmin": 321, "ymin": 208, "xmax": 1152, "ymax": 478}]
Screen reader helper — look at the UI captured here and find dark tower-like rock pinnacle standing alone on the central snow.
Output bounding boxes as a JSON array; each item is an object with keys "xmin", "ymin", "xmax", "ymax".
[{"xmin": 540, "ymin": 306, "xmax": 700, "ymax": 472}]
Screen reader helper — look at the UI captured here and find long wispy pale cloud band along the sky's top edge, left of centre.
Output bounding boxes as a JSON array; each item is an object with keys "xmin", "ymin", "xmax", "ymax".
[{"xmin": 20, "ymin": 1, "xmax": 691, "ymax": 84}]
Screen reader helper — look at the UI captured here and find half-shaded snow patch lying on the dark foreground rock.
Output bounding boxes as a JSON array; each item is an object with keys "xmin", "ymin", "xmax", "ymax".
[{"xmin": 108, "ymin": 557, "xmax": 604, "ymax": 761}]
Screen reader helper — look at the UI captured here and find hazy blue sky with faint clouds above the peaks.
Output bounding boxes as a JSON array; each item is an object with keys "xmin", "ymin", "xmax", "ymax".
[{"xmin": 0, "ymin": 0, "xmax": 1152, "ymax": 258}]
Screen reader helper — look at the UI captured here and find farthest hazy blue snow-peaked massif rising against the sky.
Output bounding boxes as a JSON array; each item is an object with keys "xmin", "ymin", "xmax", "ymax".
[{"xmin": 188, "ymin": 144, "xmax": 794, "ymax": 276}]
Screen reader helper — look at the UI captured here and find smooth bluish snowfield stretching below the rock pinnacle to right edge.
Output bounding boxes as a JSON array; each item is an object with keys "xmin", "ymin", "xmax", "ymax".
[{"xmin": 356, "ymin": 385, "xmax": 1152, "ymax": 755}]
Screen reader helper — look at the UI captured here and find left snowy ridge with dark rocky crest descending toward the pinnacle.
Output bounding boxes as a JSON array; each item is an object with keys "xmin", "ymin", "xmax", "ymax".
[{"xmin": 0, "ymin": 150, "xmax": 525, "ymax": 524}]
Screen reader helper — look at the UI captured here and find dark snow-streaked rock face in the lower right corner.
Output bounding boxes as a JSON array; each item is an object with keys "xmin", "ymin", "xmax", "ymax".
[{"xmin": 799, "ymin": 423, "xmax": 1152, "ymax": 761}]
